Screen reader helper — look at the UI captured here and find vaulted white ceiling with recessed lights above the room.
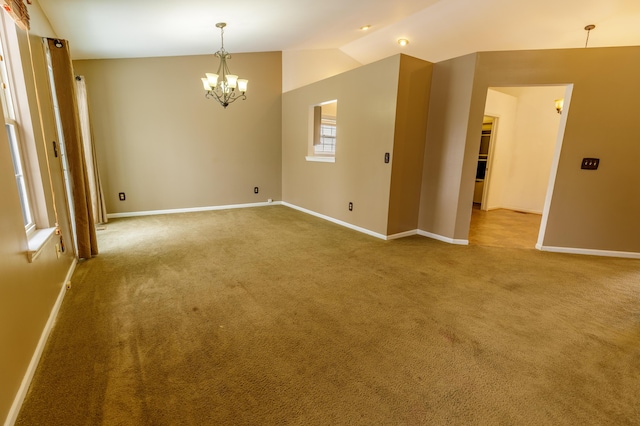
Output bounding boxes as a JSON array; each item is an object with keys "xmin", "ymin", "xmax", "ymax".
[{"xmin": 38, "ymin": 0, "xmax": 640, "ymax": 64}]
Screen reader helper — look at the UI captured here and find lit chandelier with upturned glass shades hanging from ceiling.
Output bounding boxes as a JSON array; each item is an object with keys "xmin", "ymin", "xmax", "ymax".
[{"xmin": 202, "ymin": 22, "xmax": 249, "ymax": 108}]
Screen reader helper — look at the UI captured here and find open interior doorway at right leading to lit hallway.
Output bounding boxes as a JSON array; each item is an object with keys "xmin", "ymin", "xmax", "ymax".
[{"xmin": 469, "ymin": 85, "xmax": 571, "ymax": 248}]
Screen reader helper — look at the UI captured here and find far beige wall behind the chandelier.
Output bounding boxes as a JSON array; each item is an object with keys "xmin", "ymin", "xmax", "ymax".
[{"xmin": 74, "ymin": 52, "xmax": 282, "ymax": 213}]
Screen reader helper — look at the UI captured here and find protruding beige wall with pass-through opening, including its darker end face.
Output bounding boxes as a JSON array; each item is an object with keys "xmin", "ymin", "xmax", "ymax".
[{"xmin": 282, "ymin": 55, "xmax": 432, "ymax": 236}]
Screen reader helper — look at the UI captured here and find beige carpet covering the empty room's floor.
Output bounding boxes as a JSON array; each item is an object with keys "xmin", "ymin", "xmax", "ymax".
[{"xmin": 18, "ymin": 206, "xmax": 640, "ymax": 425}]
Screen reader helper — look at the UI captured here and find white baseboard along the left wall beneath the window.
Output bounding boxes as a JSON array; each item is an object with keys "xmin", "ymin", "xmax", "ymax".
[{"xmin": 4, "ymin": 259, "xmax": 77, "ymax": 426}]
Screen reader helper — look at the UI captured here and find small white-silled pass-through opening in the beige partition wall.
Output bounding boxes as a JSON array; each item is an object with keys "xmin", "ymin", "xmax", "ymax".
[{"xmin": 306, "ymin": 100, "xmax": 338, "ymax": 163}]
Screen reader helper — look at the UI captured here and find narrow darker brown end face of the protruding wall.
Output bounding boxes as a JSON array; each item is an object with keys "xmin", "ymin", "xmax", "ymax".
[{"xmin": 387, "ymin": 55, "xmax": 433, "ymax": 235}]
